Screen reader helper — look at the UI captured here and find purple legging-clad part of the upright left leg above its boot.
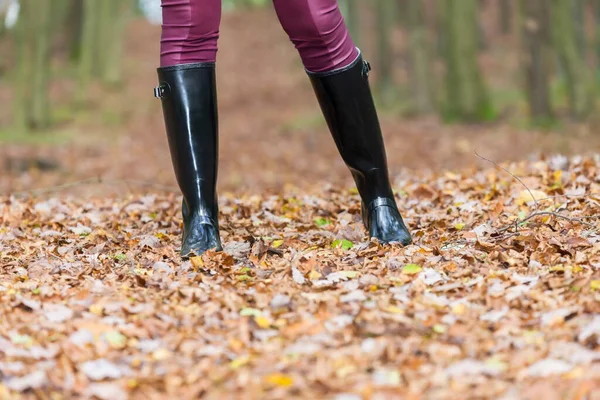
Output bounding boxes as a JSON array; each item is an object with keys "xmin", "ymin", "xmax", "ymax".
[{"xmin": 160, "ymin": 0, "xmax": 221, "ymax": 67}]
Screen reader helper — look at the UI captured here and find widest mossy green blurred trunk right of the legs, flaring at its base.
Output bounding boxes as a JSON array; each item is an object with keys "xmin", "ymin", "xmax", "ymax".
[{"xmin": 438, "ymin": 0, "xmax": 495, "ymax": 122}]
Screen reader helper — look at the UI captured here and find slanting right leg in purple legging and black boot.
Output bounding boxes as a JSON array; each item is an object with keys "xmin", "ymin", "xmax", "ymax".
[{"xmin": 273, "ymin": 0, "xmax": 411, "ymax": 245}]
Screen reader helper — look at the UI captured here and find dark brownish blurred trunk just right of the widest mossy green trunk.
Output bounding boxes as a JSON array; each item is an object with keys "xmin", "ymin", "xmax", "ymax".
[{"xmin": 521, "ymin": 0, "xmax": 553, "ymax": 123}]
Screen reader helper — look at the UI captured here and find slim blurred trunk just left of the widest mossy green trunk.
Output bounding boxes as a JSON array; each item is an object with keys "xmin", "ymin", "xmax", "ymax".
[{"xmin": 406, "ymin": 0, "xmax": 434, "ymax": 114}]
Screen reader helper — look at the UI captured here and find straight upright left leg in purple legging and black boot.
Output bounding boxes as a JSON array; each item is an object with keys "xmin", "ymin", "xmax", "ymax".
[{"xmin": 155, "ymin": 0, "xmax": 221, "ymax": 257}]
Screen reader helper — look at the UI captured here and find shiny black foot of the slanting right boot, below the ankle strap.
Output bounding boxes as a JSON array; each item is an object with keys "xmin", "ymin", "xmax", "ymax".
[{"xmin": 369, "ymin": 206, "xmax": 412, "ymax": 246}]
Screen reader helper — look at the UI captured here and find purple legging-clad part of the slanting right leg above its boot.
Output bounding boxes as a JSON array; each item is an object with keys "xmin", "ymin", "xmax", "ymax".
[{"xmin": 273, "ymin": 0, "xmax": 358, "ymax": 72}]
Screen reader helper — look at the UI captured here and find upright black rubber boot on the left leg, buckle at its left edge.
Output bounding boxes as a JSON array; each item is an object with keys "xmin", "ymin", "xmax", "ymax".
[{"xmin": 155, "ymin": 63, "xmax": 222, "ymax": 257}]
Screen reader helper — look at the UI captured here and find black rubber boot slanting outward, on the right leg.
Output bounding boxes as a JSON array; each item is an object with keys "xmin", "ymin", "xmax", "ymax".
[{"xmin": 308, "ymin": 52, "xmax": 412, "ymax": 245}]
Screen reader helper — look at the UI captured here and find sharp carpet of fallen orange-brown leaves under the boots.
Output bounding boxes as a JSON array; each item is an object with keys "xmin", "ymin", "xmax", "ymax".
[{"xmin": 0, "ymin": 158, "xmax": 600, "ymax": 400}]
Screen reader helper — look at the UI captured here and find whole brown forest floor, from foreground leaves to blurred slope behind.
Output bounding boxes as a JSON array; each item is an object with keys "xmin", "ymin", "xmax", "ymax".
[{"xmin": 0, "ymin": 6, "xmax": 600, "ymax": 400}]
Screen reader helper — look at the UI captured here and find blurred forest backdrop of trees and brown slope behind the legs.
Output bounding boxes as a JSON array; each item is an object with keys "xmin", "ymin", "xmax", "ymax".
[{"xmin": 0, "ymin": 0, "xmax": 600, "ymax": 192}]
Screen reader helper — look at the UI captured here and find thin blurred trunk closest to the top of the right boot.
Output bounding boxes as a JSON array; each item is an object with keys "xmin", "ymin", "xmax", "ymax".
[{"xmin": 373, "ymin": 0, "xmax": 396, "ymax": 104}]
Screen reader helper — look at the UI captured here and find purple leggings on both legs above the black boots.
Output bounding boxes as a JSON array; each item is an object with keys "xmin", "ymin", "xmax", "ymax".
[{"xmin": 160, "ymin": 0, "xmax": 358, "ymax": 72}]
